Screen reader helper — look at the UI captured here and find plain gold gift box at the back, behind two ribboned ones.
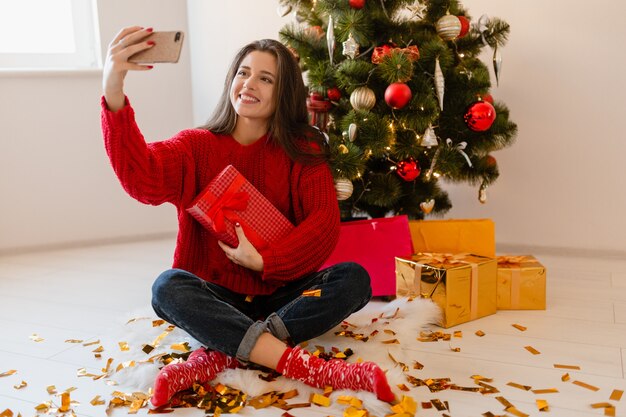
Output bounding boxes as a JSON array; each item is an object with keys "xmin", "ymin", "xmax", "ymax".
[{"xmin": 409, "ymin": 219, "xmax": 496, "ymax": 258}]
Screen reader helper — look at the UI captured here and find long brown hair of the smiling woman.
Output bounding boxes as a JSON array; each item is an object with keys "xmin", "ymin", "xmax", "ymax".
[{"xmin": 200, "ymin": 39, "xmax": 327, "ymax": 163}]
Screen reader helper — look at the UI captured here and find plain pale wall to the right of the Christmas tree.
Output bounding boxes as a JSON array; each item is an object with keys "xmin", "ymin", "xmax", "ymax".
[{"xmin": 442, "ymin": 0, "xmax": 626, "ymax": 256}]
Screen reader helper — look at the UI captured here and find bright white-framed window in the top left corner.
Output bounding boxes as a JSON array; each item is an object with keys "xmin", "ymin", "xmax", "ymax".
[{"xmin": 0, "ymin": 0, "xmax": 101, "ymax": 69}]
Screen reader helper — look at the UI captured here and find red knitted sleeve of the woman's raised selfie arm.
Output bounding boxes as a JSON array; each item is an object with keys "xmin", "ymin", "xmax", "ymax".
[{"xmin": 101, "ymin": 97, "xmax": 193, "ymax": 205}]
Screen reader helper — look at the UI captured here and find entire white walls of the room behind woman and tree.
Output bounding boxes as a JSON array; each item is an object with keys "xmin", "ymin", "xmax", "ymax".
[{"xmin": 0, "ymin": 0, "xmax": 626, "ymax": 256}]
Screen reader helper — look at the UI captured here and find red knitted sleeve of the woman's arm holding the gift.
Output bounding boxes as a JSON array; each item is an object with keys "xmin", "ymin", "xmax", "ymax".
[{"xmin": 261, "ymin": 163, "xmax": 339, "ymax": 282}]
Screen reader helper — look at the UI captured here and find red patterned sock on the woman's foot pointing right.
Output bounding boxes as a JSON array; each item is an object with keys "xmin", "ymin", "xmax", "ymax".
[{"xmin": 276, "ymin": 346, "xmax": 395, "ymax": 402}]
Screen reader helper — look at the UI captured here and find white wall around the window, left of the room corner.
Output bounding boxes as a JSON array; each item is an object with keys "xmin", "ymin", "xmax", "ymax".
[{"xmin": 0, "ymin": 0, "xmax": 192, "ymax": 253}]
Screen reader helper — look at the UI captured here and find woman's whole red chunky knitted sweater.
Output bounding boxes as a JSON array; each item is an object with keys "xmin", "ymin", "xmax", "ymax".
[{"xmin": 101, "ymin": 97, "xmax": 339, "ymax": 295}]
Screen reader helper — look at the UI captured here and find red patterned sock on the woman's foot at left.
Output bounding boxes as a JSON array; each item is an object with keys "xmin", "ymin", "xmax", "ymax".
[{"xmin": 150, "ymin": 348, "xmax": 238, "ymax": 407}]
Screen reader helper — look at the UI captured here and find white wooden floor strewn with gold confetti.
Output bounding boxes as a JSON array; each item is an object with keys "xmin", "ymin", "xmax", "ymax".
[{"xmin": 0, "ymin": 240, "xmax": 626, "ymax": 417}]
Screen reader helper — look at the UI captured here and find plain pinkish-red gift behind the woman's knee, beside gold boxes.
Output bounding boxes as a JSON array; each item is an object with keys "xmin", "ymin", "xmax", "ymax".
[{"xmin": 322, "ymin": 216, "xmax": 413, "ymax": 296}]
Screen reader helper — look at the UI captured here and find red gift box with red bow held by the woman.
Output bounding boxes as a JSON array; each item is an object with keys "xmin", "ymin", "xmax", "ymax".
[{"xmin": 187, "ymin": 165, "xmax": 294, "ymax": 250}]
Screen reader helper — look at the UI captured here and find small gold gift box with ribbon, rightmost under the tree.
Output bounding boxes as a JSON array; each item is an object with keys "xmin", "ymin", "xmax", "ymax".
[{"xmin": 497, "ymin": 255, "xmax": 546, "ymax": 310}]
